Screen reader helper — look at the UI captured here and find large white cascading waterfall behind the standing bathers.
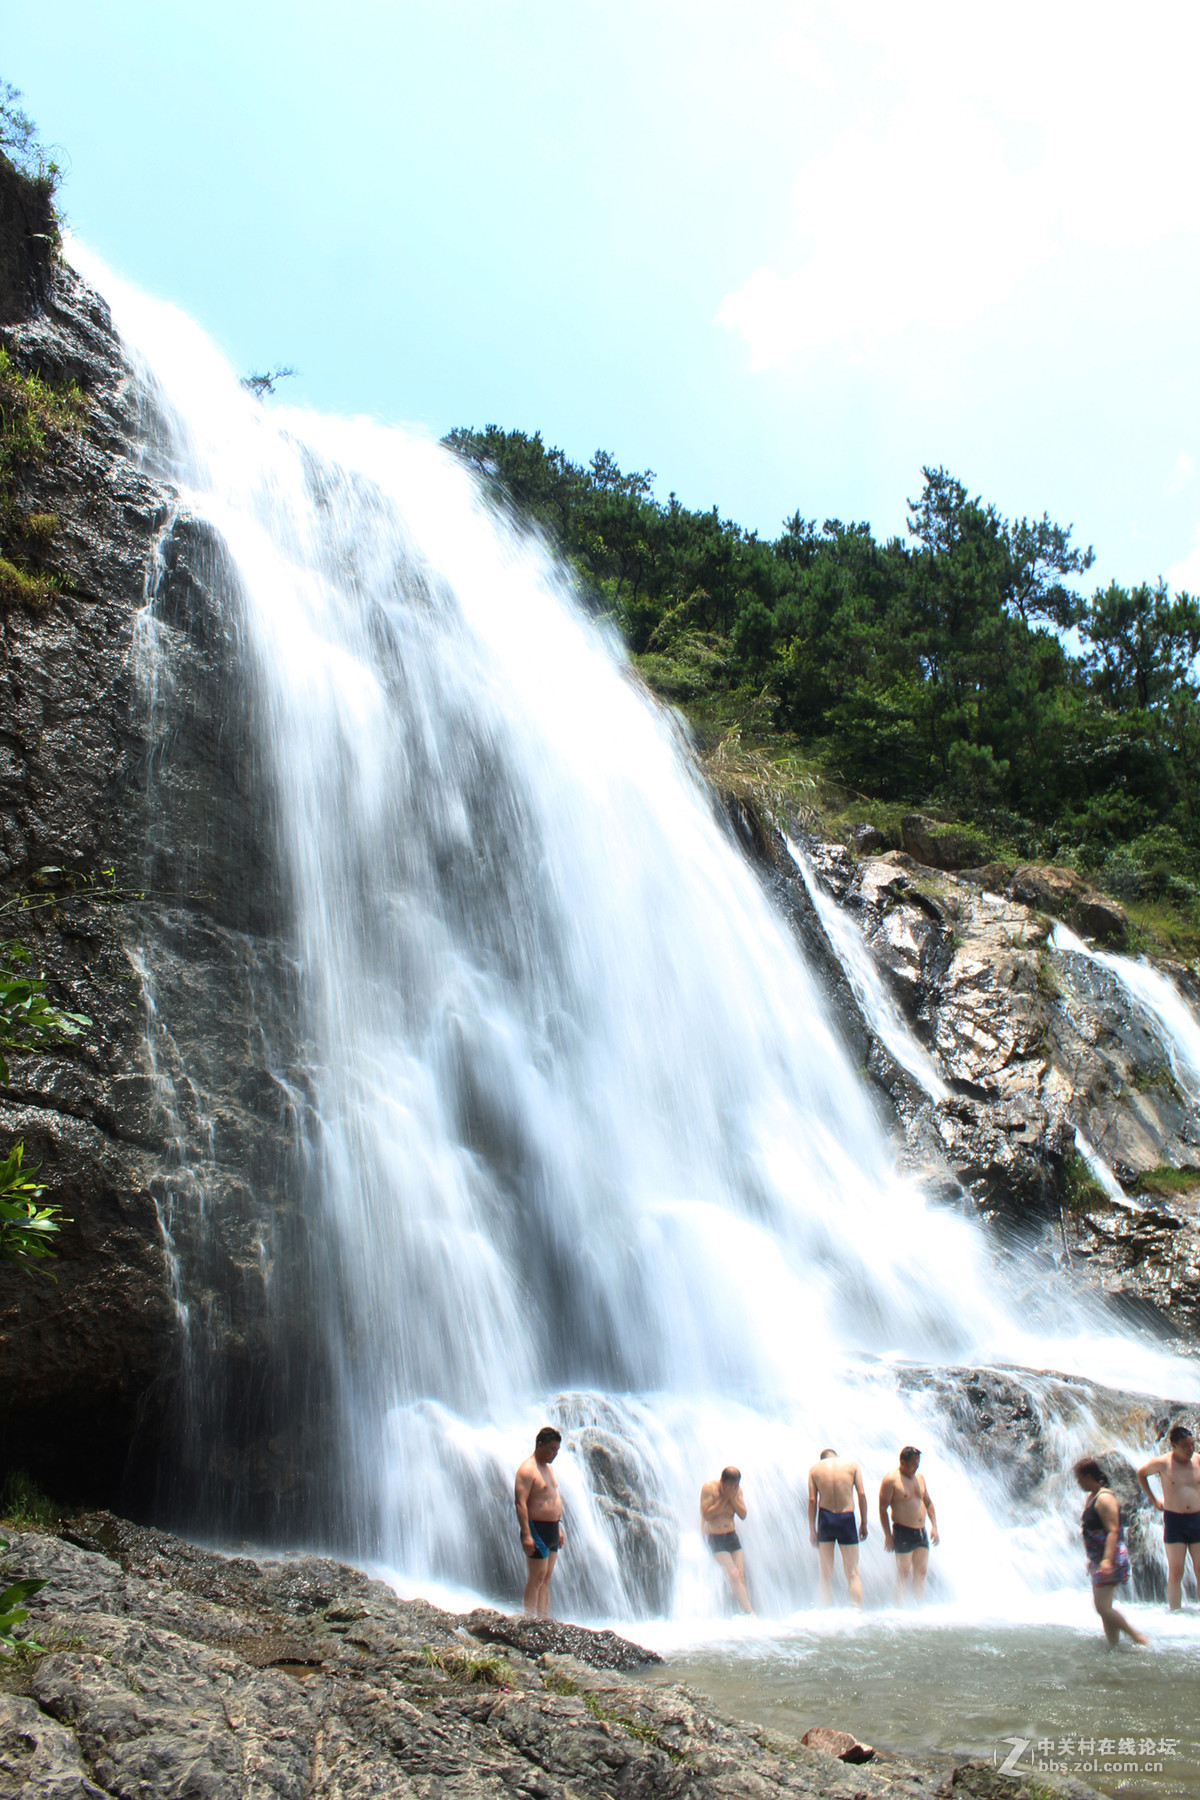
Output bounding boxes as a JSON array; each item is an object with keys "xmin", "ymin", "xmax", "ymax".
[{"xmin": 75, "ymin": 246, "xmax": 1196, "ymax": 1641}]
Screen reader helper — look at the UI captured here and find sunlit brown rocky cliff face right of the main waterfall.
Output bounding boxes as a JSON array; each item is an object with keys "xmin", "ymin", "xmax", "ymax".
[{"xmin": 775, "ymin": 837, "xmax": 1200, "ymax": 1343}]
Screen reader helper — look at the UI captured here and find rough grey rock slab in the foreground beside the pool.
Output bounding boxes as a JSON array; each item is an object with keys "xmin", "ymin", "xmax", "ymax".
[{"xmin": 0, "ymin": 1516, "xmax": 1088, "ymax": 1800}]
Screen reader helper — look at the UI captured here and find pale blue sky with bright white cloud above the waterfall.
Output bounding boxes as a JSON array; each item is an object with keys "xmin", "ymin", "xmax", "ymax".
[{"xmin": 9, "ymin": 0, "xmax": 1200, "ymax": 590}]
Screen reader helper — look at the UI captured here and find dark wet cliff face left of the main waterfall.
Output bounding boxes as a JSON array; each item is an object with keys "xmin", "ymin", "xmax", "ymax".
[{"xmin": 0, "ymin": 158, "xmax": 320, "ymax": 1516}]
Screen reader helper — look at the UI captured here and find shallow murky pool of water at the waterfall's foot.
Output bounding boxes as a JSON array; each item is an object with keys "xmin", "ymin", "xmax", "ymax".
[{"xmin": 642, "ymin": 1595, "xmax": 1200, "ymax": 1800}]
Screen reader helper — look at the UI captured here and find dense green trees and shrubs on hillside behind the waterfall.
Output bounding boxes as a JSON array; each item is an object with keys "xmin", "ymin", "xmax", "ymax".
[{"xmin": 446, "ymin": 425, "xmax": 1200, "ymax": 954}]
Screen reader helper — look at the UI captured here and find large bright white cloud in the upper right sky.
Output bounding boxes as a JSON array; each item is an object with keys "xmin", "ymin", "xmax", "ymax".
[{"xmin": 716, "ymin": 0, "xmax": 1200, "ymax": 369}]
